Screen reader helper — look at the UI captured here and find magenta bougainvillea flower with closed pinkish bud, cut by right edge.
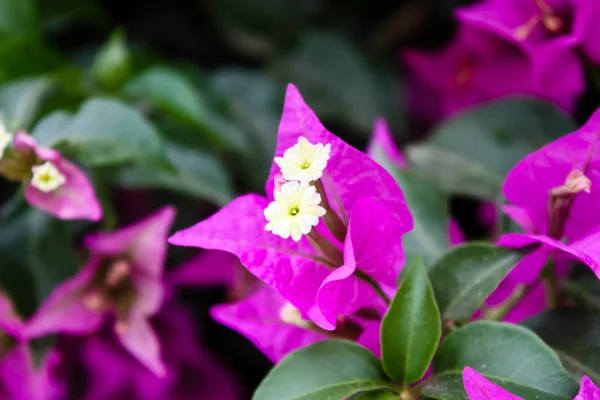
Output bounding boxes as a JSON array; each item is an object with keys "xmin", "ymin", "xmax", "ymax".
[{"xmin": 499, "ymin": 111, "xmax": 600, "ymax": 283}]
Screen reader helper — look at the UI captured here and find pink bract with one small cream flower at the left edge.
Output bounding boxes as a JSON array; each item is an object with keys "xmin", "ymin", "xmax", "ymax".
[{"xmin": 0, "ymin": 131, "xmax": 102, "ymax": 221}]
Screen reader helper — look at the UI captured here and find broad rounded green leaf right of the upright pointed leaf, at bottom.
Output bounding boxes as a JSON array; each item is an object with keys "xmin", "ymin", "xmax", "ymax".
[{"xmin": 422, "ymin": 321, "xmax": 579, "ymax": 400}]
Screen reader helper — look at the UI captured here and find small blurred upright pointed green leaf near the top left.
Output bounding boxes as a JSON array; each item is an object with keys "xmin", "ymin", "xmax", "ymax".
[{"xmin": 92, "ymin": 31, "xmax": 131, "ymax": 90}]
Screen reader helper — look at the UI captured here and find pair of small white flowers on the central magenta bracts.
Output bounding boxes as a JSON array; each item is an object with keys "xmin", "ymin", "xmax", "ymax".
[{"xmin": 264, "ymin": 137, "xmax": 331, "ymax": 242}]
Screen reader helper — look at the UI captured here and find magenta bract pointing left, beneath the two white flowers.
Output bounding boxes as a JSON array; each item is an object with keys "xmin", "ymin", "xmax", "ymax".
[{"xmin": 169, "ymin": 195, "xmax": 329, "ymax": 324}]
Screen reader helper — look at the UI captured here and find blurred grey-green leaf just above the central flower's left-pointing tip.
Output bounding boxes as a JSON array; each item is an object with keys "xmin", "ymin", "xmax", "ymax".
[{"xmin": 111, "ymin": 143, "xmax": 233, "ymax": 206}]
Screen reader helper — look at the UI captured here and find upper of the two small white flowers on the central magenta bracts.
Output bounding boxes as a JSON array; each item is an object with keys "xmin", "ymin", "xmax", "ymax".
[{"xmin": 275, "ymin": 136, "xmax": 331, "ymax": 182}]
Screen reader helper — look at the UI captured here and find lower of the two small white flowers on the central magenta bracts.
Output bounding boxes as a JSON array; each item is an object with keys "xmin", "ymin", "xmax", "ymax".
[{"xmin": 264, "ymin": 181, "xmax": 325, "ymax": 242}]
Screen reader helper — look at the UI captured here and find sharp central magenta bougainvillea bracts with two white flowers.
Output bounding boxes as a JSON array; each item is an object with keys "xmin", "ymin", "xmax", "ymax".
[{"xmin": 170, "ymin": 85, "xmax": 412, "ymax": 330}]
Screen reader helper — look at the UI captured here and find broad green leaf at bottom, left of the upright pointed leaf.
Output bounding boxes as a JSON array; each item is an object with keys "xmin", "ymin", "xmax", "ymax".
[{"xmin": 252, "ymin": 340, "xmax": 391, "ymax": 400}]
